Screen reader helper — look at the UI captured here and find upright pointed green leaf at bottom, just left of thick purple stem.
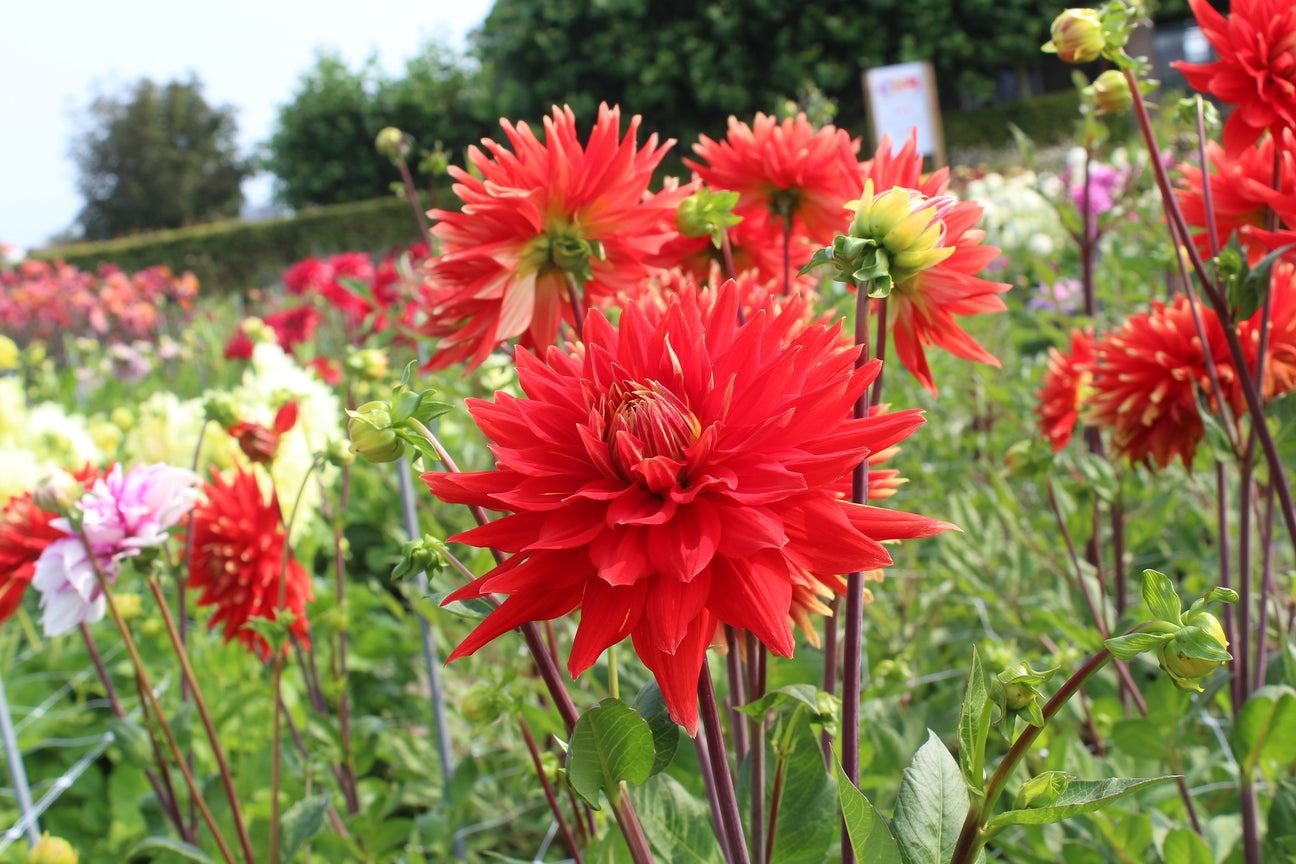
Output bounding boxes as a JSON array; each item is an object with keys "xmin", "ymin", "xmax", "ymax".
[{"xmin": 770, "ymin": 710, "xmax": 841, "ymax": 864}]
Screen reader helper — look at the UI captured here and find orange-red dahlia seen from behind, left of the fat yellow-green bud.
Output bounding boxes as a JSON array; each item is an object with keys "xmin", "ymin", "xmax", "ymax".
[{"xmin": 684, "ymin": 113, "xmax": 863, "ymax": 248}]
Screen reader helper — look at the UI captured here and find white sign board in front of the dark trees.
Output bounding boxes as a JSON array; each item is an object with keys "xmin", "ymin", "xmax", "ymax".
[{"xmin": 864, "ymin": 61, "xmax": 945, "ymax": 165}]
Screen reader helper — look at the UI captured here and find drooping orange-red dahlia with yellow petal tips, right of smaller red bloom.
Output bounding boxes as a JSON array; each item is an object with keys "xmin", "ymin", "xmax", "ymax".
[{"xmin": 1083, "ymin": 294, "xmax": 1244, "ymax": 468}]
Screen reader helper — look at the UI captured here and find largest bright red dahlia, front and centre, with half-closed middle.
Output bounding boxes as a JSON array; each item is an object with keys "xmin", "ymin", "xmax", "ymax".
[{"xmin": 424, "ymin": 284, "xmax": 951, "ymax": 733}]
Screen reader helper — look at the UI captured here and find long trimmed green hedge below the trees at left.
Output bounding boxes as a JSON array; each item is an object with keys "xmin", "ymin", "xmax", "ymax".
[{"xmin": 30, "ymin": 189, "xmax": 443, "ymax": 294}]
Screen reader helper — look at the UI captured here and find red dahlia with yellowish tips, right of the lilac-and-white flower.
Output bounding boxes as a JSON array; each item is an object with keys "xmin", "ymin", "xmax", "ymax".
[{"xmin": 188, "ymin": 468, "xmax": 314, "ymax": 659}]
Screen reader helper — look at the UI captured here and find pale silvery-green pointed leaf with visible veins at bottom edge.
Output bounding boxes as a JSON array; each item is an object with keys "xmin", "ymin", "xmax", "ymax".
[{"xmin": 892, "ymin": 729, "xmax": 971, "ymax": 864}]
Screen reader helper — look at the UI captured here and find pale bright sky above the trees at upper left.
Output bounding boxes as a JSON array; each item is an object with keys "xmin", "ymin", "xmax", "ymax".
[{"xmin": 0, "ymin": 0, "xmax": 491, "ymax": 249}]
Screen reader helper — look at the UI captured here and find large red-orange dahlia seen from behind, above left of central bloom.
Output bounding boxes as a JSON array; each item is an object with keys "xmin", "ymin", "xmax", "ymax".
[{"xmin": 424, "ymin": 105, "xmax": 692, "ymax": 368}]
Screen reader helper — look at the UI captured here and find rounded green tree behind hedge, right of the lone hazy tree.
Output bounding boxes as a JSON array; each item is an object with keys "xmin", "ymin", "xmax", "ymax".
[{"xmin": 262, "ymin": 43, "xmax": 489, "ymax": 209}]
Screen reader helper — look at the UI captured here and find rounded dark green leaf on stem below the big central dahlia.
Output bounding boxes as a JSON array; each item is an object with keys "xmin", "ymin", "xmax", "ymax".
[{"xmin": 568, "ymin": 698, "xmax": 656, "ymax": 810}]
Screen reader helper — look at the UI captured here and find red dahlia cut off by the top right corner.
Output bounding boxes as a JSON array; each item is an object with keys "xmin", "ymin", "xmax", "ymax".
[{"xmin": 1172, "ymin": 0, "xmax": 1296, "ymax": 150}]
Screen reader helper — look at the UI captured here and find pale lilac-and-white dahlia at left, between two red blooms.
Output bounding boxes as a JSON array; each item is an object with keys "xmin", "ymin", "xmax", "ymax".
[{"xmin": 31, "ymin": 464, "xmax": 201, "ymax": 636}]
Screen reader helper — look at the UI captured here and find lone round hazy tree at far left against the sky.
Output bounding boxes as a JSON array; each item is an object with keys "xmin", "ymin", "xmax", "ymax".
[{"xmin": 73, "ymin": 76, "xmax": 251, "ymax": 240}]
